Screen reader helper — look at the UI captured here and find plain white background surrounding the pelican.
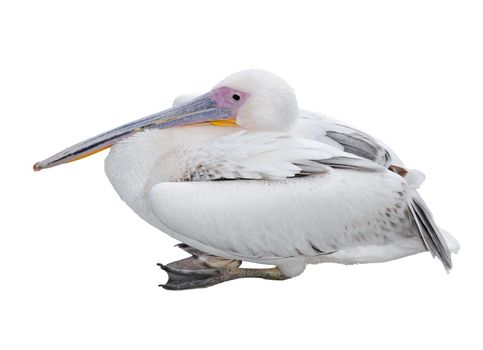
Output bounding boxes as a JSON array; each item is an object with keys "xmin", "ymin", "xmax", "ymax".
[{"xmin": 0, "ymin": 0, "xmax": 483, "ymax": 350}]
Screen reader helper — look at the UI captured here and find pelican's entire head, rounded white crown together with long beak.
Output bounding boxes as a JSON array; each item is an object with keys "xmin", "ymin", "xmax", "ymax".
[{"xmin": 33, "ymin": 70, "xmax": 298, "ymax": 171}]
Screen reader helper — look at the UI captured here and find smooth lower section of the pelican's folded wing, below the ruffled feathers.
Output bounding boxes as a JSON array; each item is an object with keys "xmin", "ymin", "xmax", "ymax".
[{"xmin": 149, "ymin": 169, "xmax": 412, "ymax": 263}]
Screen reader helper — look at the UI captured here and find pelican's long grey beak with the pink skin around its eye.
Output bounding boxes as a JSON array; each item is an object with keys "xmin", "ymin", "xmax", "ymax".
[{"xmin": 33, "ymin": 87, "xmax": 250, "ymax": 171}]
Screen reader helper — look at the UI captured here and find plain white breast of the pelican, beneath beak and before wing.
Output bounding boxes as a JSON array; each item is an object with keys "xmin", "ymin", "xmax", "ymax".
[{"xmin": 105, "ymin": 125, "xmax": 237, "ymax": 224}]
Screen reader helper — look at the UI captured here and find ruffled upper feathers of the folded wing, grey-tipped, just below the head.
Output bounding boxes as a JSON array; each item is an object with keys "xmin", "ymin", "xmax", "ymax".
[{"xmin": 168, "ymin": 131, "xmax": 381, "ymax": 181}]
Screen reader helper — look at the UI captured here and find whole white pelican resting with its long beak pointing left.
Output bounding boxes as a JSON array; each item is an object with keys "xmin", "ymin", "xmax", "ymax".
[{"xmin": 34, "ymin": 70, "xmax": 459, "ymax": 290}]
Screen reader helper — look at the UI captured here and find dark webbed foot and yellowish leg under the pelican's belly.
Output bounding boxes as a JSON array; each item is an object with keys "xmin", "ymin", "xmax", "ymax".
[{"xmin": 158, "ymin": 244, "xmax": 289, "ymax": 290}]
